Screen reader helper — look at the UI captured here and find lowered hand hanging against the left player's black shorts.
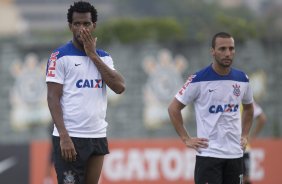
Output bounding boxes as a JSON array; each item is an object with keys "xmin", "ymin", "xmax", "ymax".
[{"xmin": 60, "ymin": 136, "xmax": 77, "ymax": 162}]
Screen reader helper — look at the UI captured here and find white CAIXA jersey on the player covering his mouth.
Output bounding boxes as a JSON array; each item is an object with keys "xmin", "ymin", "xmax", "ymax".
[{"xmin": 46, "ymin": 42, "xmax": 114, "ymax": 138}]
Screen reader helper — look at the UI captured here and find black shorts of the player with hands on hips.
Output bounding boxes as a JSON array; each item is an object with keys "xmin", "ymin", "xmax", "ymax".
[{"xmin": 194, "ymin": 156, "xmax": 243, "ymax": 184}]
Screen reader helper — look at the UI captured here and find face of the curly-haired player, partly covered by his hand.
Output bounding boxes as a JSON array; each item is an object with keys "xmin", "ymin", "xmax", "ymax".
[{"xmin": 69, "ymin": 12, "xmax": 96, "ymax": 45}]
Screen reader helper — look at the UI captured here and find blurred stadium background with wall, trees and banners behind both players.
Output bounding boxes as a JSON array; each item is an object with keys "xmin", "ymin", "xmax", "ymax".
[{"xmin": 0, "ymin": 0, "xmax": 282, "ymax": 184}]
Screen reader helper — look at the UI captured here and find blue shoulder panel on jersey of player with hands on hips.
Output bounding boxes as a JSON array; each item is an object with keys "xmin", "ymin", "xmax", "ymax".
[{"xmin": 192, "ymin": 65, "xmax": 249, "ymax": 83}]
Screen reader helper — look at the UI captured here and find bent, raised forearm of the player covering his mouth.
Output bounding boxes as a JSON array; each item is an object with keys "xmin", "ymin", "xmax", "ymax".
[{"xmin": 90, "ymin": 55, "xmax": 125, "ymax": 94}]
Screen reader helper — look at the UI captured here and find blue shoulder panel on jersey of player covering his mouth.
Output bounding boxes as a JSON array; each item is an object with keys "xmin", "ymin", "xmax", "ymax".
[{"xmin": 54, "ymin": 41, "xmax": 109, "ymax": 59}]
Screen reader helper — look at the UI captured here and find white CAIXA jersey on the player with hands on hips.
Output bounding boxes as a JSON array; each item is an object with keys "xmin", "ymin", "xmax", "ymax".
[{"xmin": 175, "ymin": 65, "xmax": 253, "ymax": 158}]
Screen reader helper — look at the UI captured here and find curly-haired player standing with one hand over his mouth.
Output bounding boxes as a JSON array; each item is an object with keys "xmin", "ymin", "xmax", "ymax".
[{"xmin": 46, "ymin": 1, "xmax": 125, "ymax": 184}]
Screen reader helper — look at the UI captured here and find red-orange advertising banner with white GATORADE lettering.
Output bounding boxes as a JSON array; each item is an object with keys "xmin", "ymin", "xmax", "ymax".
[{"xmin": 25, "ymin": 139, "xmax": 282, "ymax": 184}]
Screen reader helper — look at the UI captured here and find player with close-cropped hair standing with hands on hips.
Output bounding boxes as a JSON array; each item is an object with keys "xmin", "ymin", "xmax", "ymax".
[{"xmin": 168, "ymin": 32, "xmax": 253, "ymax": 184}]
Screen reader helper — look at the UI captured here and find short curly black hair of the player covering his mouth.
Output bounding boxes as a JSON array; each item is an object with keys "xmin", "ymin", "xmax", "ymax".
[{"xmin": 67, "ymin": 1, "xmax": 97, "ymax": 23}]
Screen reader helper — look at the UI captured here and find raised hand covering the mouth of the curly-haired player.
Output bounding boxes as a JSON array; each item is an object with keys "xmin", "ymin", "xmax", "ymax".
[{"xmin": 80, "ymin": 28, "xmax": 97, "ymax": 56}]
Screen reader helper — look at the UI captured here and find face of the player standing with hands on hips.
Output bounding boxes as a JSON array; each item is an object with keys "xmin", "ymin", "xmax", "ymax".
[{"xmin": 211, "ymin": 38, "xmax": 235, "ymax": 67}]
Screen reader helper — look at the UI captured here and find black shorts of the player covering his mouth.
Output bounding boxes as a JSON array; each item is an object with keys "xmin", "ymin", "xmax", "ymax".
[{"xmin": 52, "ymin": 136, "xmax": 109, "ymax": 184}]
